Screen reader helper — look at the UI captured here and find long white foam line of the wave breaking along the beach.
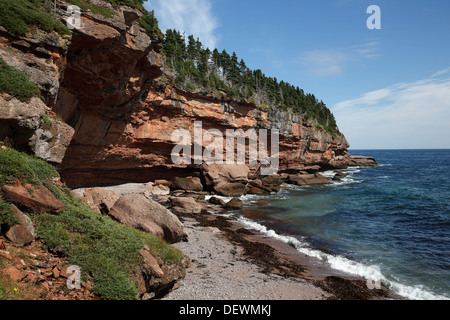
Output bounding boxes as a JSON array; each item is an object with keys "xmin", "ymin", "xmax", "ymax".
[{"xmin": 230, "ymin": 212, "xmax": 449, "ymax": 300}]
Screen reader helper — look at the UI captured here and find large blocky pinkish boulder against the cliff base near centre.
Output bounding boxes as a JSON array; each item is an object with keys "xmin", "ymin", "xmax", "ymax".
[{"xmin": 201, "ymin": 164, "xmax": 250, "ymax": 189}]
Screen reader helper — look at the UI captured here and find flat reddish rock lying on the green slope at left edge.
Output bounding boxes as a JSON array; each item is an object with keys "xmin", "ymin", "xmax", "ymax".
[{"xmin": 1, "ymin": 181, "xmax": 64, "ymax": 214}]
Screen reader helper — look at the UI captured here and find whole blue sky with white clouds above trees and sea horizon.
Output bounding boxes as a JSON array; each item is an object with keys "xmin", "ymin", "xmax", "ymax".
[{"xmin": 146, "ymin": 0, "xmax": 450, "ymax": 149}]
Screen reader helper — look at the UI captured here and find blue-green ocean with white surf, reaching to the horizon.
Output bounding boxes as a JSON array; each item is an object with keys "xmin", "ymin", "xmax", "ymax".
[{"xmin": 212, "ymin": 150, "xmax": 450, "ymax": 300}]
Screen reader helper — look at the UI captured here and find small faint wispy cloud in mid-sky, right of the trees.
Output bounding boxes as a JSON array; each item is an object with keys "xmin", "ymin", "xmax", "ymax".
[{"xmin": 299, "ymin": 41, "xmax": 380, "ymax": 77}]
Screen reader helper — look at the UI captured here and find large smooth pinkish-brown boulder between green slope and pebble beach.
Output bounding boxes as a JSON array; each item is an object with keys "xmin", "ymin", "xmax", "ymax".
[{"xmin": 109, "ymin": 194, "xmax": 187, "ymax": 243}]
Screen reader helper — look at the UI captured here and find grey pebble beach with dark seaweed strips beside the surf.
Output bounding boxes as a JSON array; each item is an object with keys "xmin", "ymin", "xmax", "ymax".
[{"xmin": 163, "ymin": 208, "xmax": 404, "ymax": 300}]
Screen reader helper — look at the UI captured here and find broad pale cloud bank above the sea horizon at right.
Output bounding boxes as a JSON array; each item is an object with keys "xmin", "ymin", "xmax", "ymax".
[{"xmin": 332, "ymin": 69, "xmax": 450, "ymax": 149}]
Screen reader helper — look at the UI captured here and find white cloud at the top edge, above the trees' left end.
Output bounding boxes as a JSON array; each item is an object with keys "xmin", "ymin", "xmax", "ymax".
[{"xmin": 145, "ymin": 0, "xmax": 217, "ymax": 49}]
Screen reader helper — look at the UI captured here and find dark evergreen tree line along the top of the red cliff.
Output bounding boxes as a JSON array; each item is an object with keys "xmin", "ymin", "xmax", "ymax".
[{"xmin": 163, "ymin": 29, "xmax": 339, "ymax": 134}]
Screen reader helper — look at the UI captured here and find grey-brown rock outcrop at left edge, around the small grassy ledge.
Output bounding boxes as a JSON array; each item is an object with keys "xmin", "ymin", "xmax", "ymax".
[{"xmin": 0, "ymin": 15, "xmax": 74, "ymax": 163}]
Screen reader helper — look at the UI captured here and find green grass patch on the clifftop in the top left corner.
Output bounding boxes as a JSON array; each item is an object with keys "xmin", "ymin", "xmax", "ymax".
[{"xmin": 0, "ymin": 0, "xmax": 70, "ymax": 36}]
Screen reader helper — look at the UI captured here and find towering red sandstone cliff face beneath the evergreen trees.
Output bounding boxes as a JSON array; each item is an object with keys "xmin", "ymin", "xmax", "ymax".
[{"xmin": 2, "ymin": 0, "xmax": 362, "ymax": 187}]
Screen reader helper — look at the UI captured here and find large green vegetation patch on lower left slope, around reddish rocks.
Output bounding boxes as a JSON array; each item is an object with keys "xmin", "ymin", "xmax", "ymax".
[{"xmin": 0, "ymin": 149, "xmax": 183, "ymax": 300}]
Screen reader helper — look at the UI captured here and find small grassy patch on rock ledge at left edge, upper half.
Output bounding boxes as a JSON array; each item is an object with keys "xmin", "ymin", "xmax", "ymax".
[{"xmin": 0, "ymin": 57, "xmax": 41, "ymax": 101}]
